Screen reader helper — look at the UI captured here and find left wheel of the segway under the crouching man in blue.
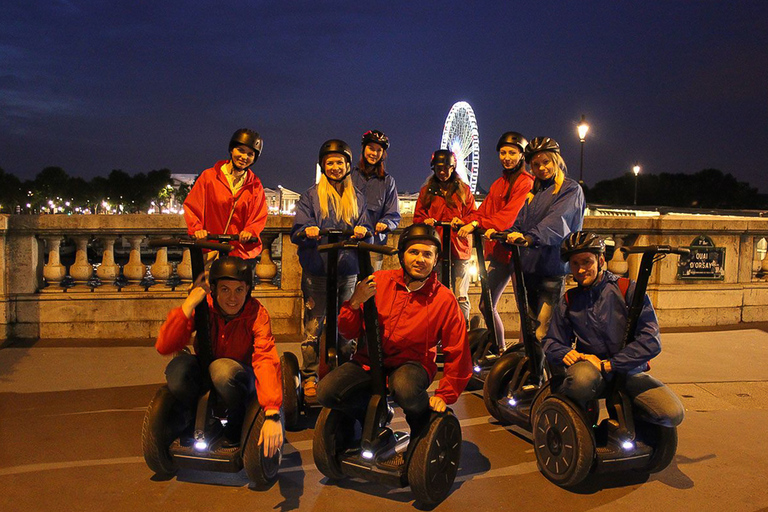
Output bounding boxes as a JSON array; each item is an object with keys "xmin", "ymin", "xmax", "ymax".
[{"xmin": 533, "ymin": 396, "xmax": 595, "ymax": 487}]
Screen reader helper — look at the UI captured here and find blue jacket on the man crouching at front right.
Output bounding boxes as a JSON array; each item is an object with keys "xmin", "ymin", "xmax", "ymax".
[{"xmin": 542, "ymin": 270, "xmax": 661, "ymax": 374}]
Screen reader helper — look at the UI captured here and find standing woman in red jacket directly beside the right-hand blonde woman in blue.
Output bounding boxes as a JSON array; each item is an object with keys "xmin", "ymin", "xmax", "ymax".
[{"xmin": 454, "ymin": 132, "xmax": 533, "ymax": 353}]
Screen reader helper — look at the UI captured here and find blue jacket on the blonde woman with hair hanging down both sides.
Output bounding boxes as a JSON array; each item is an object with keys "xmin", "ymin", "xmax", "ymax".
[{"xmin": 291, "ymin": 185, "xmax": 373, "ymax": 276}]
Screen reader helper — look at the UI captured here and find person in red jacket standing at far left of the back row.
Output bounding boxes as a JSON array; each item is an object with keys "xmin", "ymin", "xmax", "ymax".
[{"xmin": 184, "ymin": 128, "xmax": 267, "ymax": 259}]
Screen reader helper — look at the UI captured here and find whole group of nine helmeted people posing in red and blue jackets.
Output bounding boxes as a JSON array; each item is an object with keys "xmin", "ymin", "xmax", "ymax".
[{"xmin": 156, "ymin": 129, "xmax": 682, "ymax": 462}]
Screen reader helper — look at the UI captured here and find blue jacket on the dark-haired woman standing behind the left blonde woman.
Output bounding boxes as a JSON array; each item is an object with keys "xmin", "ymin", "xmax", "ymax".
[{"xmin": 352, "ymin": 167, "xmax": 400, "ymax": 245}]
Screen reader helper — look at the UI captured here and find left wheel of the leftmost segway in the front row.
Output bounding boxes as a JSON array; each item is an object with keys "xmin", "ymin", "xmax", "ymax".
[{"xmin": 141, "ymin": 386, "xmax": 182, "ymax": 478}]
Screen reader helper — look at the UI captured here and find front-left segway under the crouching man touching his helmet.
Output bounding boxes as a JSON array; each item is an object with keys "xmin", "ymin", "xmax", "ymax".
[{"xmin": 141, "ymin": 235, "xmax": 281, "ymax": 489}]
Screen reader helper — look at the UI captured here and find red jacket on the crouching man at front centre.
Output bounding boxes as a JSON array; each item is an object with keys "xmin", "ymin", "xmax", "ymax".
[{"xmin": 338, "ymin": 269, "xmax": 472, "ymax": 404}]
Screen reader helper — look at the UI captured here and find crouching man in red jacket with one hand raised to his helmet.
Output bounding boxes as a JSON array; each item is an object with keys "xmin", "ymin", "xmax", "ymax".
[{"xmin": 155, "ymin": 256, "xmax": 283, "ymax": 457}]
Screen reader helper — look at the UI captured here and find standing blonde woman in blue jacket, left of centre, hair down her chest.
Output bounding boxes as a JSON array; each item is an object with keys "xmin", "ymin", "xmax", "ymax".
[{"xmin": 291, "ymin": 139, "xmax": 373, "ymax": 400}]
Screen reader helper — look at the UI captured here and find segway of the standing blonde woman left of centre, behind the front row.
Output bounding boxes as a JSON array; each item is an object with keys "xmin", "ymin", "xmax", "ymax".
[{"xmin": 280, "ymin": 229, "xmax": 362, "ymax": 430}]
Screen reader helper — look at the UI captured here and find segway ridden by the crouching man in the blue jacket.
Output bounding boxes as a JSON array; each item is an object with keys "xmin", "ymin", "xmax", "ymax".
[{"xmin": 532, "ymin": 245, "xmax": 690, "ymax": 487}]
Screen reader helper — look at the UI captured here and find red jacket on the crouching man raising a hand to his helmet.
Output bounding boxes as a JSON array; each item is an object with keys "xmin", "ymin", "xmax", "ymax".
[{"xmin": 155, "ymin": 295, "xmax": 283, "ymax": 409}]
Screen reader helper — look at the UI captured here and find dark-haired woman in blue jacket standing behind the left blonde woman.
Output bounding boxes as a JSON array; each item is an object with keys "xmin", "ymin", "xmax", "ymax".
[{"xmin": 352, "ymin": 130, "xmax": 400, "ymax": 271}]
